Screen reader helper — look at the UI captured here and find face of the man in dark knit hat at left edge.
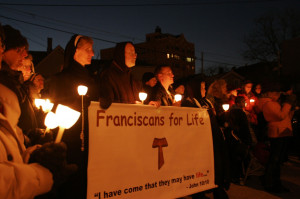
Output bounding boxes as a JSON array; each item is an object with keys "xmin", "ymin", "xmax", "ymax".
[{"xmin": 3, "ymin": 46, "xmax": 28, "ymax": 70}]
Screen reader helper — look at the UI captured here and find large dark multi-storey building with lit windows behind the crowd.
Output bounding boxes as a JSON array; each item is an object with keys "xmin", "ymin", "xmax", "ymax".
[{"xmin": 100, "ymin": 27, "xmax": 195, "ymax": 78}]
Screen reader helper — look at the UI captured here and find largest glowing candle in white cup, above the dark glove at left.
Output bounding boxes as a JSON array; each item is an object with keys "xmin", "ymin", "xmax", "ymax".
[{"xmin": 55, "ymin": 104, "xmax": 80, "ymax": 143}]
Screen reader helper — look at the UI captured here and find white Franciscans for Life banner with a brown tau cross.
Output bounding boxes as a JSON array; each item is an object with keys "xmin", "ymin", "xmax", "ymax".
[{"xmin": 87, "ymin": 102, "xmax": 215, "ymax": 199}]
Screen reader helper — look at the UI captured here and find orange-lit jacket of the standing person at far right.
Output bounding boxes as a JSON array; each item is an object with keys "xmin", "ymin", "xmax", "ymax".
[{"xmin": 259, "ymin": 98, "xmax": 293, "ymax": 138}]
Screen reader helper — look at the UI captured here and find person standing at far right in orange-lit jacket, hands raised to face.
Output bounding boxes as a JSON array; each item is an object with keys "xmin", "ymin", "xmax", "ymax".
[{"xmin": 259, "ymin": 82, "xmax": 296, "ymax": 193}]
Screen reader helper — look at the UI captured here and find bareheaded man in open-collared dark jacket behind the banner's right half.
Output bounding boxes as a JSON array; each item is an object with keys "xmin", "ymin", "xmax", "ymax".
[{"xmin": 149, "ymin": 65, "xmax": 181, "ymax": 106}]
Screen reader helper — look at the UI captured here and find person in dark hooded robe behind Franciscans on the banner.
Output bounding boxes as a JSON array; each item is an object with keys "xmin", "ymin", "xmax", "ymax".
[{"xmin": 99, "ymin": 42, "xmax": 141, "ymax": 108}]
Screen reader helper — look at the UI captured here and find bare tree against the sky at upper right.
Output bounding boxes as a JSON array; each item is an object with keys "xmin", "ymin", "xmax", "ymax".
[{"xmin": 243, "ymin": 10, "xmax": 300, "ymax": 62}]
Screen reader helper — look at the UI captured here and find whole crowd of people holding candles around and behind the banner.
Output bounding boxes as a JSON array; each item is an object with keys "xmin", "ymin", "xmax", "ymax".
[{"xmin": 0, "ymin": 25, "xmax": 297, "ymax": 198}]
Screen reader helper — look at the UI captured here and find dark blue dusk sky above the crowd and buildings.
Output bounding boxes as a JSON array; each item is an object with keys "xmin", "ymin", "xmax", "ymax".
[{"xmin": 0, "ymin": 0, "xmax": 300, "ymax": 72}]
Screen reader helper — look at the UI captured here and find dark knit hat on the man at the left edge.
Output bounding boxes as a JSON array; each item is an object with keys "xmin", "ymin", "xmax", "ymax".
[{"xmin": 3, "ymin": 25, "xmax": 28, "ymax": 51}]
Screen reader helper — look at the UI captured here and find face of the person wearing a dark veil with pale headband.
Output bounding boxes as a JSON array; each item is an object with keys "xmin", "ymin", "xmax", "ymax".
[{"xmin": 74, "ymin": 41, "xmax": 95, "ymax": 66}]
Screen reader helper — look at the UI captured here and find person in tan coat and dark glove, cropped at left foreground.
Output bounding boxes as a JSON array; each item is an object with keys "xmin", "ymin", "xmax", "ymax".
[{"xmin": 0, "ymin": 83, "xmax": 76, "ymax": 199}]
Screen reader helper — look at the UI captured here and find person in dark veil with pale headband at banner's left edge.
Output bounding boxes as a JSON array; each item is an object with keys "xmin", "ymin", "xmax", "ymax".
[{"xmin": 44, "ymin": 34, "xmax": 98, "ymax": 198}]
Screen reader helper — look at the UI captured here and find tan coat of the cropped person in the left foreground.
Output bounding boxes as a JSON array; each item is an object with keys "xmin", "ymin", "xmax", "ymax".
[{"xmin": 0, "ymin": 84, "xmax": 53, "ymax": 199}]
